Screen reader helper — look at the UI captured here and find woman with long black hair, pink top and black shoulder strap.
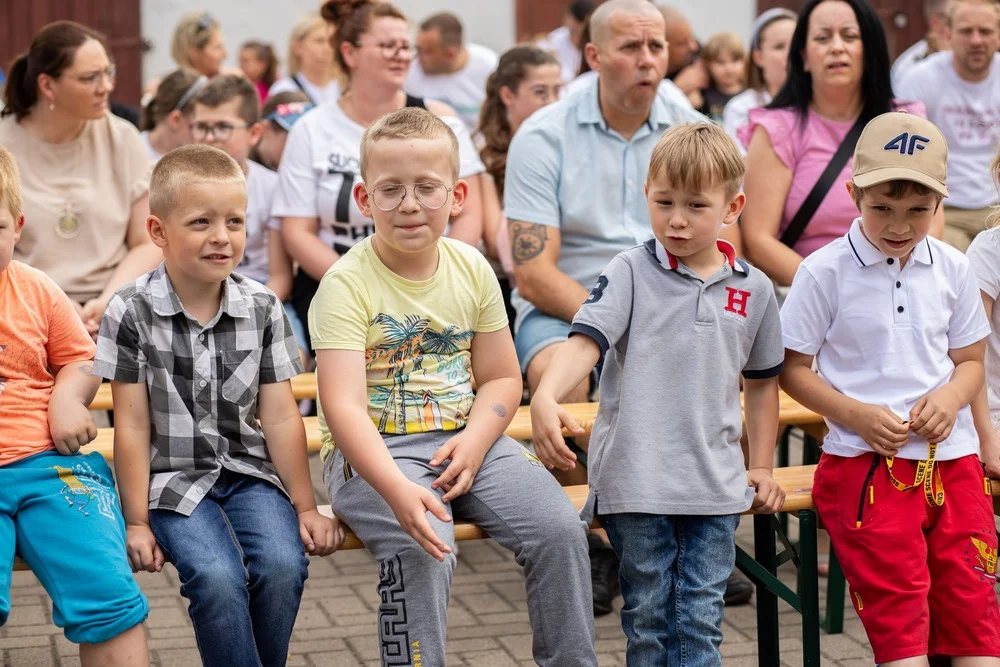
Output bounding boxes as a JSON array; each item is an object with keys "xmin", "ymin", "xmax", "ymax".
[{"xmin": 740, "ymin": 0, "xmax": 942, "ymax": 286}]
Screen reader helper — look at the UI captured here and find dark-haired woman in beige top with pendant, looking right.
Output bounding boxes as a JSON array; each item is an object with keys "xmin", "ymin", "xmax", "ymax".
[{"xmin": 0, "ymin": 21, "xmax": 162, "ymax": 336}]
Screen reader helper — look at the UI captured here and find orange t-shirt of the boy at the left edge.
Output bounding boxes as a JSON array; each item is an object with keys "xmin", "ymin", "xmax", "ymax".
[{"xmin": 0, "ymin": 261, "xmax": 96, "ymax": 466}]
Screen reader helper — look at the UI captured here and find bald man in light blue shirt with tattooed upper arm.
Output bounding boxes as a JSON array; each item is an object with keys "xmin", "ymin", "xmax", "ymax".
[{"xmin": 504, "ymin": 0, "xmax": 752, "ymax": 615}]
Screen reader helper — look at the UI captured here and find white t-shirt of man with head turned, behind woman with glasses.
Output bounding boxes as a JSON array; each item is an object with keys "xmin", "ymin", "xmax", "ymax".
[{"xmin": 403, "ymin": 44, "xmax": 499, "ymax": 132}]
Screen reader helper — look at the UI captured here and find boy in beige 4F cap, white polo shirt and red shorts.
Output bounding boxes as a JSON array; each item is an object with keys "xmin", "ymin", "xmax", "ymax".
[{"xmin": 781, "ymin": 113, "xmax": 1000, "ymax": 667}]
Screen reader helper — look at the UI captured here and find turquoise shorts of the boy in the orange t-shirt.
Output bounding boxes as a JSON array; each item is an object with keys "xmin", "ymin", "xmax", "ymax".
[{"xmin": 0, "ymin": 451, "xmax": 149, "ymax": 644}]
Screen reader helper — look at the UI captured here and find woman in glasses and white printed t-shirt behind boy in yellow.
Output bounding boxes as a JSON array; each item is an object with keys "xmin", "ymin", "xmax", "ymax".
[{"xmin": 271, "ymin": 0, "xmax": 484, "ymax": 352}]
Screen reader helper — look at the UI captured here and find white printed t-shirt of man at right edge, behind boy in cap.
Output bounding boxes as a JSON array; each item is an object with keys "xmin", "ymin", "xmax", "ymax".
[{"xmin": 896, "ymin": 51, "xmax": 1000, "ymax": 209}]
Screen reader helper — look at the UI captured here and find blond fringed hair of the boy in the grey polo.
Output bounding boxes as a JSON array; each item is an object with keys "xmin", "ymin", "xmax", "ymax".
[{"xmin": 646, "ymin": 122, "xmax": 746, "ymax": 197}]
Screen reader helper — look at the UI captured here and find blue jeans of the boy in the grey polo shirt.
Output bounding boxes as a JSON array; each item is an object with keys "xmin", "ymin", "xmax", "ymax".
[{"xmin": 600, "ymin": 514, "xmax": 740, "ymax": 667}]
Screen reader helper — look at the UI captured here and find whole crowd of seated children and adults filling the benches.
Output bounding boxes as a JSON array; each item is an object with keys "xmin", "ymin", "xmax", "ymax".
[{"xmin": 0, "ymin": 0, "xmax": 1000, "ymax": 667}]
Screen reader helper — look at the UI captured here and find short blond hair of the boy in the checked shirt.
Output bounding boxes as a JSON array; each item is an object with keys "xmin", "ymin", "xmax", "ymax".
[{"xmin": 149, "ymin": 144, "xmax": 246, "ymax": 220}]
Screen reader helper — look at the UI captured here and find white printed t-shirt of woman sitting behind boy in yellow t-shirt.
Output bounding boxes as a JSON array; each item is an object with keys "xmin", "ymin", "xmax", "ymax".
[{"xmin": 271, "ymin": 104, "xmax": 486, "ymax": 255}]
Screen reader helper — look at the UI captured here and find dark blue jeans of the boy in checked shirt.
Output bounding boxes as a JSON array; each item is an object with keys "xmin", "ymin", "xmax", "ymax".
[{"xmin": 149, "ymin": 470, "xmax": 308, "ymax": 667}]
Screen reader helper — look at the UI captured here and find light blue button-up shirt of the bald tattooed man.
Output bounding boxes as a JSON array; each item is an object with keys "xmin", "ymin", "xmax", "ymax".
[{"xmin": 504, "ymin": 78, "xmax": 705, "ymax": 322}]
